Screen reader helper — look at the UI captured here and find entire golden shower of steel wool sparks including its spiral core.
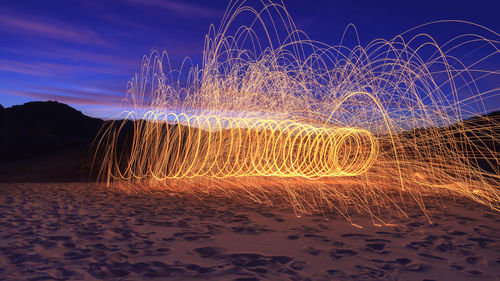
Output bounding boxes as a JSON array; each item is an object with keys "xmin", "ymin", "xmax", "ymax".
[{"xmin": 96, "ymin": 1, "xmax": 500, "ymax": 218}]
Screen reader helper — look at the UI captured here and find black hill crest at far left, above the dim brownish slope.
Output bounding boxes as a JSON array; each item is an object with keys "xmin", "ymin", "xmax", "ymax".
[{"xmin": 0, "ymin": 101, "xmax": 103, "ymax": 163}]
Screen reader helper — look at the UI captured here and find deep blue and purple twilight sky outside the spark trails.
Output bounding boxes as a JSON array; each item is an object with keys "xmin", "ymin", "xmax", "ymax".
[{"xmin": 0, "ymin": 0, "xmax": 500, "ymax": 117}]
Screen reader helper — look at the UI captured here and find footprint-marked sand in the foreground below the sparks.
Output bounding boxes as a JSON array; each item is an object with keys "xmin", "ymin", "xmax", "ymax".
[{"xmin": 0, "ymin": 183, "xmax": 500, "ymax": 281}]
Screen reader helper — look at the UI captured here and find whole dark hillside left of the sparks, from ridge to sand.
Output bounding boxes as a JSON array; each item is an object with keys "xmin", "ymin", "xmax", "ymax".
[{"xmin": 0, "ymin": 101, "xmax": 104, "ymax": 182}]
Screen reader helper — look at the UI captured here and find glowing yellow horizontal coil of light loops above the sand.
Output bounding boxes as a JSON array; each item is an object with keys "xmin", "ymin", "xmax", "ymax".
[{"xmin": 126, "ymin": 113, "xmax": 379, "ymax": 180}]
